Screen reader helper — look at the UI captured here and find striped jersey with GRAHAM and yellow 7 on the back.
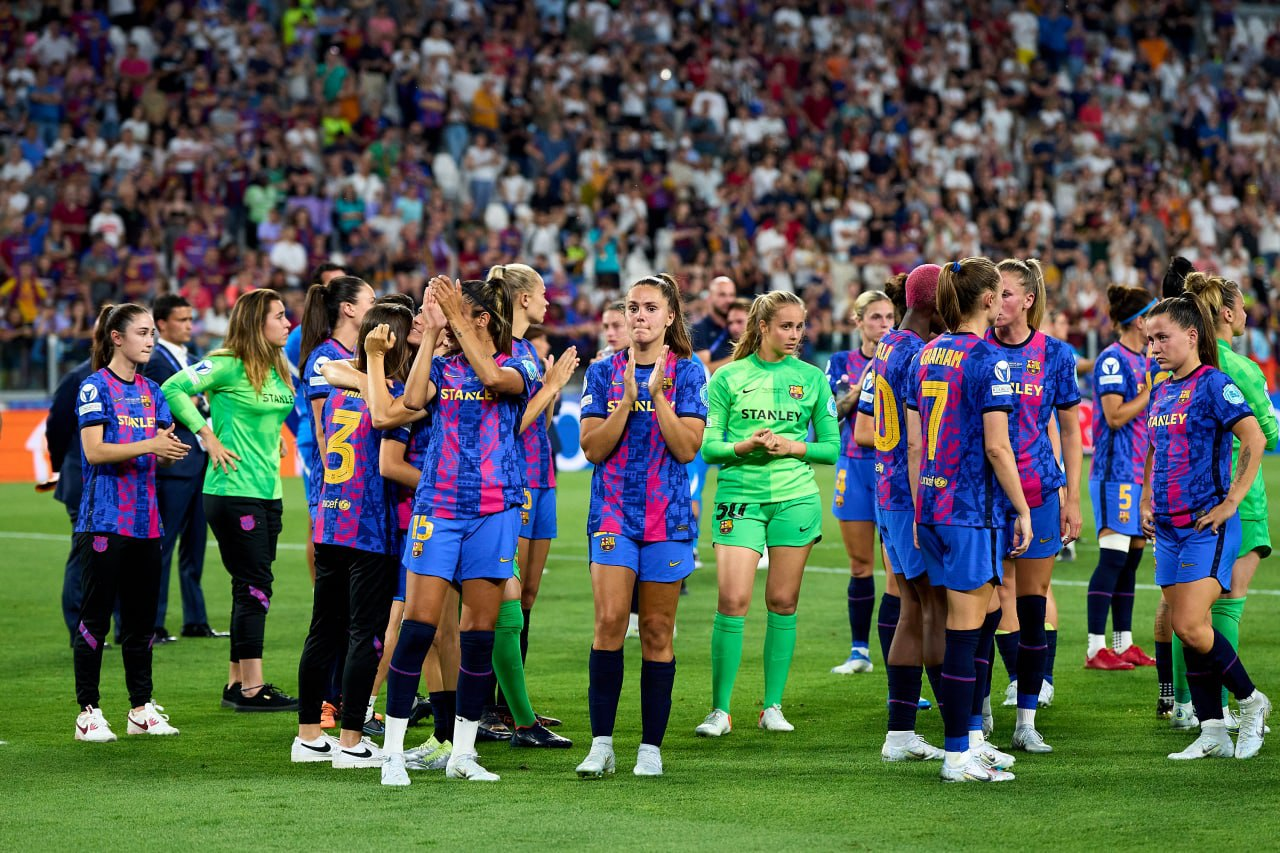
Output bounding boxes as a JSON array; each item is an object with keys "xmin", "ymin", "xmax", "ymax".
[{"xmin": 906, "ymin": 333, "xmax": 1014, "ymax": 528}]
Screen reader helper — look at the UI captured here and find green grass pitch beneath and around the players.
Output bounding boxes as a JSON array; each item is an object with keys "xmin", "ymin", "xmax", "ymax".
[{"xmin": 0, "ymin": 457, "xmax": 1280, "ymax": 850}]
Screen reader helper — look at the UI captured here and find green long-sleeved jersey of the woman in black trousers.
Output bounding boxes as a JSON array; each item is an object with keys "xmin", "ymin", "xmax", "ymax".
[{"xmin": 160, "ymin": 355, "xmax": 293, "ymax": 500}]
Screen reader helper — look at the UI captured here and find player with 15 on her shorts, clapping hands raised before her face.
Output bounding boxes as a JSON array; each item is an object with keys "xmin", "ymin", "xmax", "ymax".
[{"xmin": 381, "ymin": 277, "xmax": 538, "ymax": 785}]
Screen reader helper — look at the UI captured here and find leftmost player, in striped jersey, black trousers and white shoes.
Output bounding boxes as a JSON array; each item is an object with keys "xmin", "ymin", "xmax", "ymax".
[{"xmin": 72, "ymin": 304, "xmax": 191, "ymax": 743}]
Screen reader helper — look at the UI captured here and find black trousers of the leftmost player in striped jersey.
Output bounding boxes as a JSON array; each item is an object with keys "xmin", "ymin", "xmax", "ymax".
[{"xmin": 72, "ymin": 533, "xmax": 160, "ymax": 708}]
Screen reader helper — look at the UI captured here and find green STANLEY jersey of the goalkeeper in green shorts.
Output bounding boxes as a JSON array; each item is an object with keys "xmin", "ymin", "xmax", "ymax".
[{"xmin": 703, "ymin": 355, "xmax": 840, "ymax": 503}]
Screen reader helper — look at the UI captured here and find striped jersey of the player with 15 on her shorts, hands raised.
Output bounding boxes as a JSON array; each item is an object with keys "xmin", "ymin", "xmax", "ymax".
[{"xmin": 413, "ymin": 353, "xmax": 538, "ymax": 519}]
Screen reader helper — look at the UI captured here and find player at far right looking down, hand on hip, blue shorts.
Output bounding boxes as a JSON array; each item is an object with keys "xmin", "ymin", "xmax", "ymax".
[{"xmin": 1140, "ymin": 296, "xmax": 1271, "ymax": 760}]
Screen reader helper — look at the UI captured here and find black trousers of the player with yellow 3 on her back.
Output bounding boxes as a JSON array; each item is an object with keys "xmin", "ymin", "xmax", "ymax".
[{"xmin": 298, "ymin": 544, "xmax": 399, "ymax": 731}]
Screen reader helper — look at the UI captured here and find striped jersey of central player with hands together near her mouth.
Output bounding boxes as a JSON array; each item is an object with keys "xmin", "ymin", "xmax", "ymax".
[{"xmin": 582, "ymin": 350, "xmax": 707, "ymax": 542}]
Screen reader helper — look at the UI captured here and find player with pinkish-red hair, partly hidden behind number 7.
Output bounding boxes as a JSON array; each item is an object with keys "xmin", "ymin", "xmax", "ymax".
[{"xmin": 854, "ymin": 264, "xmax": 946, "ymax": 762}]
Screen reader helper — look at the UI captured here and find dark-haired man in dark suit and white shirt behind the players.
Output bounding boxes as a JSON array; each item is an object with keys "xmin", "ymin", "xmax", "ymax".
[{"xmin": 143, "ymin": 293, "xmax": 227, "ymax": 643}]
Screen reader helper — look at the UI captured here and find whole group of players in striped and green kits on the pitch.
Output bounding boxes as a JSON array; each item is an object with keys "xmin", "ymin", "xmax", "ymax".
[{"xmin": 62, "ymin": 249, "xmax": 1276, "ymax": 785}]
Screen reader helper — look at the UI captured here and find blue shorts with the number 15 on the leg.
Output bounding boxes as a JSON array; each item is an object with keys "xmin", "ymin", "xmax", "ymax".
[{"xmin": 403, "ymin": 507, "xmax": 520, "ymax": 584}]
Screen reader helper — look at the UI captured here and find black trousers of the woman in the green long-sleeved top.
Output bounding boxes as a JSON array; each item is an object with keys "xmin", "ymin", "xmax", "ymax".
[{"xmin": 205, "ymin": 494, "xmax": 283, "ymax": 663}]
